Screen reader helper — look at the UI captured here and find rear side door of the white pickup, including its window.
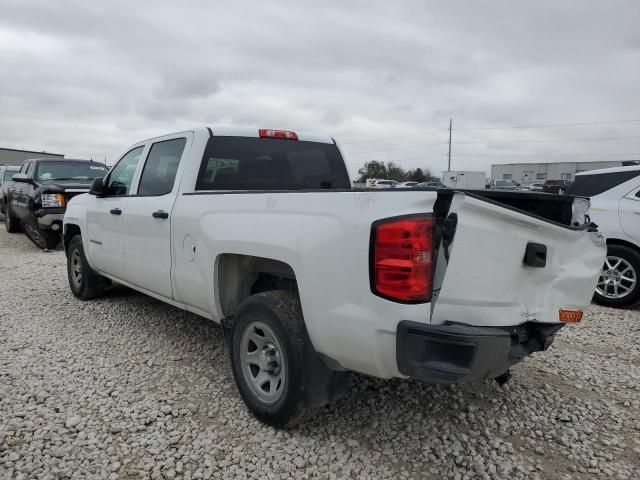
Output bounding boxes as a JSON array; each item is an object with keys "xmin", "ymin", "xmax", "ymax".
[{"xmin": 122, "ymin": 133, "xmax": 192, "ymax": 299}]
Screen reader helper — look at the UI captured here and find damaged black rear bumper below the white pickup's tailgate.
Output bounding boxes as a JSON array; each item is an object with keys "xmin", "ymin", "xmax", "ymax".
[{"xmin": 396, "ymin": 320, "xmax": 563, "ymax": 383}]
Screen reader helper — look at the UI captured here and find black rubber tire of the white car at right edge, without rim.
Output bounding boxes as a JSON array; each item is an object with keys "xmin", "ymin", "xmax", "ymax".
[{"xmin": 593, "ymin": 244, "xmax": 640, "ymax": 308}]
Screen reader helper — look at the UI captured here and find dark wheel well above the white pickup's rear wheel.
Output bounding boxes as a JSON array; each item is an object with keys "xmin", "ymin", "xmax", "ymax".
[{"xmin": 217, "ymin": 253, "xmax": 298, "ymax": 317}]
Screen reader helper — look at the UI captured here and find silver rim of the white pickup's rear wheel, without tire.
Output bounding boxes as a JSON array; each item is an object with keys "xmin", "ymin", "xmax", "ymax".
[{"xmin": 240, "ymin": 321, "xmax": 287, "ymax": 404}]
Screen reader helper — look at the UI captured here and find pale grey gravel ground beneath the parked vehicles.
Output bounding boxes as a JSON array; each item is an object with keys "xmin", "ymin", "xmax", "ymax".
[{"xmin": 0, "ymin": 228, "xmax": 640, "ymax": 479}]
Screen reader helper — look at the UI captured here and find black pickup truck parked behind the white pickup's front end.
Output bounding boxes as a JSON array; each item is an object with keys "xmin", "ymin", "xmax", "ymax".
[{"xmin": 4, "ymin": 159, "xmax": 108, "ymax": 249}]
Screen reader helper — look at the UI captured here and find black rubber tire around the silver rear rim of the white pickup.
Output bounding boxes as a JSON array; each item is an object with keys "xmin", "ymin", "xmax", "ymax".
[{"xmin": 231, "ymin": 290, "xmax": 316, "ymax": 428}]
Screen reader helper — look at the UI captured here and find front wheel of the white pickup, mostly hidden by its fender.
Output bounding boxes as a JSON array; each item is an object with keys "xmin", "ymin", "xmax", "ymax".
[{"xmin": 67, "ymin": 235, "xmax": 111, "ymax": 300}]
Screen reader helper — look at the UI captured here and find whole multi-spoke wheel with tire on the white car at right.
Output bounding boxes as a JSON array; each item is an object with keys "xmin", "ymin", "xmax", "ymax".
[{"xmin": 594, "ymin": 245, "xmax": 640, "ymax": 308}]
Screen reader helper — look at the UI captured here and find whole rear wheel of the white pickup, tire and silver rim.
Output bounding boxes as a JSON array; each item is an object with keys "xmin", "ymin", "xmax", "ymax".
[{"xmin": 231, "ymin": 290, "xmax": 313, "ymax": 428}]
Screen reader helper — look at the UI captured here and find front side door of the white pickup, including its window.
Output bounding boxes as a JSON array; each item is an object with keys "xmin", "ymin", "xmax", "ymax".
[{"xmin": 85, "ymin": 145, "xmax": 144, "ymax": 278}]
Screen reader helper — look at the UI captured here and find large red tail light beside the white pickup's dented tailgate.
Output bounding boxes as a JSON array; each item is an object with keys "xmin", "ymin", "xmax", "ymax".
[{"xmin": 371, "ymin": 216, "xmax": 433, "ymax": 303}]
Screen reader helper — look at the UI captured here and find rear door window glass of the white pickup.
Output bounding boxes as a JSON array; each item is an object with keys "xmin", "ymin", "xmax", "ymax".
[{"xmin": 138, "ymin": 138, "xmax": 187, "ymax": 196}]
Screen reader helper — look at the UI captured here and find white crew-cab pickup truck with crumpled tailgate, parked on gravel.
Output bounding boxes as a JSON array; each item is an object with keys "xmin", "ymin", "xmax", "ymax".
[{"xmin": 63, "ymin": 128, "xmax": 606, "ymax": 427}]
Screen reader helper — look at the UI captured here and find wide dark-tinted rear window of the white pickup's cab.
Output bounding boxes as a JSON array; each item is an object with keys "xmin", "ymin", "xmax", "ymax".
[{"xmin": 196, "ymin": 136, "xmax": 351, "ymax": 190}]
